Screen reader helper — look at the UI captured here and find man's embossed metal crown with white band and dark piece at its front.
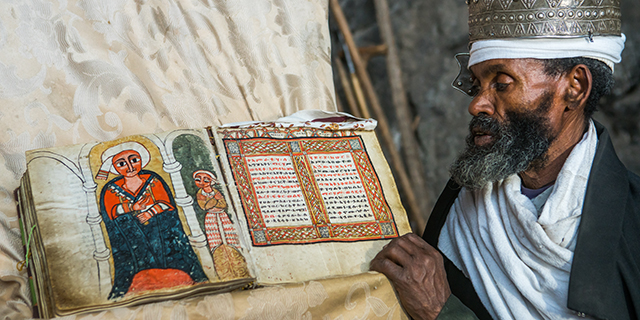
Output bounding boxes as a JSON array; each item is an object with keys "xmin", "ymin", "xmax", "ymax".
[{"xmin": 452, "ymin": 0, "xmax": 625, "ymax": 95}]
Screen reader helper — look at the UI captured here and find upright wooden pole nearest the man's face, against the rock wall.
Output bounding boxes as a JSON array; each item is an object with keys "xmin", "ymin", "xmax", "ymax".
[{"xmin": 374, "ymin": 0, "xmax": 431, "ymax": 225}]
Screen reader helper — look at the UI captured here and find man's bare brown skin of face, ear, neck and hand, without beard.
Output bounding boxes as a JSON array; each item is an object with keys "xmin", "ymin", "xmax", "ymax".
[{"xmin": 370, "ymin": 59, "xmax": 592, "ymax": 319}]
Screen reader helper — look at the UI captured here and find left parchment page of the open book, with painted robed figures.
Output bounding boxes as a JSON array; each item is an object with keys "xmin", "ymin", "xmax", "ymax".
[{"xmin": 27, "ymin": 129, "xmax": 253, "ymax": 315}]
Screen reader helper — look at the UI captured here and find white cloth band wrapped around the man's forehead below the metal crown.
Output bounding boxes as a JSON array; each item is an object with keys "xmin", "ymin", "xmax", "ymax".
[{"xmin": 469, "ymin": 34, "xmax": 626, "ymax": 71}]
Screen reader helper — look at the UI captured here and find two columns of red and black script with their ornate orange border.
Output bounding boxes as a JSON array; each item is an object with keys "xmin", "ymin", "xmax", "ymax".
[{"xmin": 223, "ymin": 136, "xmax": 398, "ymax": 245}]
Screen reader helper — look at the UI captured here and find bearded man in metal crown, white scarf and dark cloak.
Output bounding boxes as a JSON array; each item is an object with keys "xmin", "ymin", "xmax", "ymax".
[{"xmin": 371, "ymin": 0, "xmax": 640, "ymax": 319}]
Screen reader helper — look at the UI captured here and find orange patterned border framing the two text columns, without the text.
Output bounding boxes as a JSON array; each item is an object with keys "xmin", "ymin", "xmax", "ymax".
[{"xmin": 219, "ymin": 134, "xmax": 398, "ymax": 246}]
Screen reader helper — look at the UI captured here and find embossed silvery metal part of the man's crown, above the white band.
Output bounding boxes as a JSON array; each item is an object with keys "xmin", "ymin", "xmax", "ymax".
[{"xmin": 467, "ymin": 0, "xmax": 620, "ymax": 42}]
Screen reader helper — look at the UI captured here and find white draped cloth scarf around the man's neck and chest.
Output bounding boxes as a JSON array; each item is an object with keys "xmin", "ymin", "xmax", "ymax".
[{"xmin": 438, "ymin": 122, "xmax": 598, "ymax": 319}]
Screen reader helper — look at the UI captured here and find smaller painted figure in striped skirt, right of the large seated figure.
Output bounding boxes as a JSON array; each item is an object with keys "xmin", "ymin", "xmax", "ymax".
[{"xmin": 193, "ymin": 170, "xmax": 250, "ymax": 280}]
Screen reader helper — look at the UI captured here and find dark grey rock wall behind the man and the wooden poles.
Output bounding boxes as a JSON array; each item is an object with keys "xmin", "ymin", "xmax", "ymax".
[{"xmin": 331, "ymin": 0, "xmax": 640, "ymax": 222}]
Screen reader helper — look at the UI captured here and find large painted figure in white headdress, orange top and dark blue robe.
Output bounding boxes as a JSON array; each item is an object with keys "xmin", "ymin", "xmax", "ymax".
[{"xmin": 96, "ymin": 142, "xmax": 208, "ymax": 299}]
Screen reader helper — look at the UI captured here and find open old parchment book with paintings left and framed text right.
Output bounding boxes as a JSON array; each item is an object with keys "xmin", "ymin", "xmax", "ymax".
[{"xmin": 17, "ymin": 113, "xmax": 410, "ymax": 317}]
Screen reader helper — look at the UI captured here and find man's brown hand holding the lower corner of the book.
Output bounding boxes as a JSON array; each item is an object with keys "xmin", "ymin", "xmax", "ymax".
[{"xmin": 370, "ymin": 233, "xmax": 451, "ymax": 320}]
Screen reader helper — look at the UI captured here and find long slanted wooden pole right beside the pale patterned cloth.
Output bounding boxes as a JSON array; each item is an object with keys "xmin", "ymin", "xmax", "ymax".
[{"xmin": 329, "ymin": 0, "xmax": 425, "ymax": 234}]
